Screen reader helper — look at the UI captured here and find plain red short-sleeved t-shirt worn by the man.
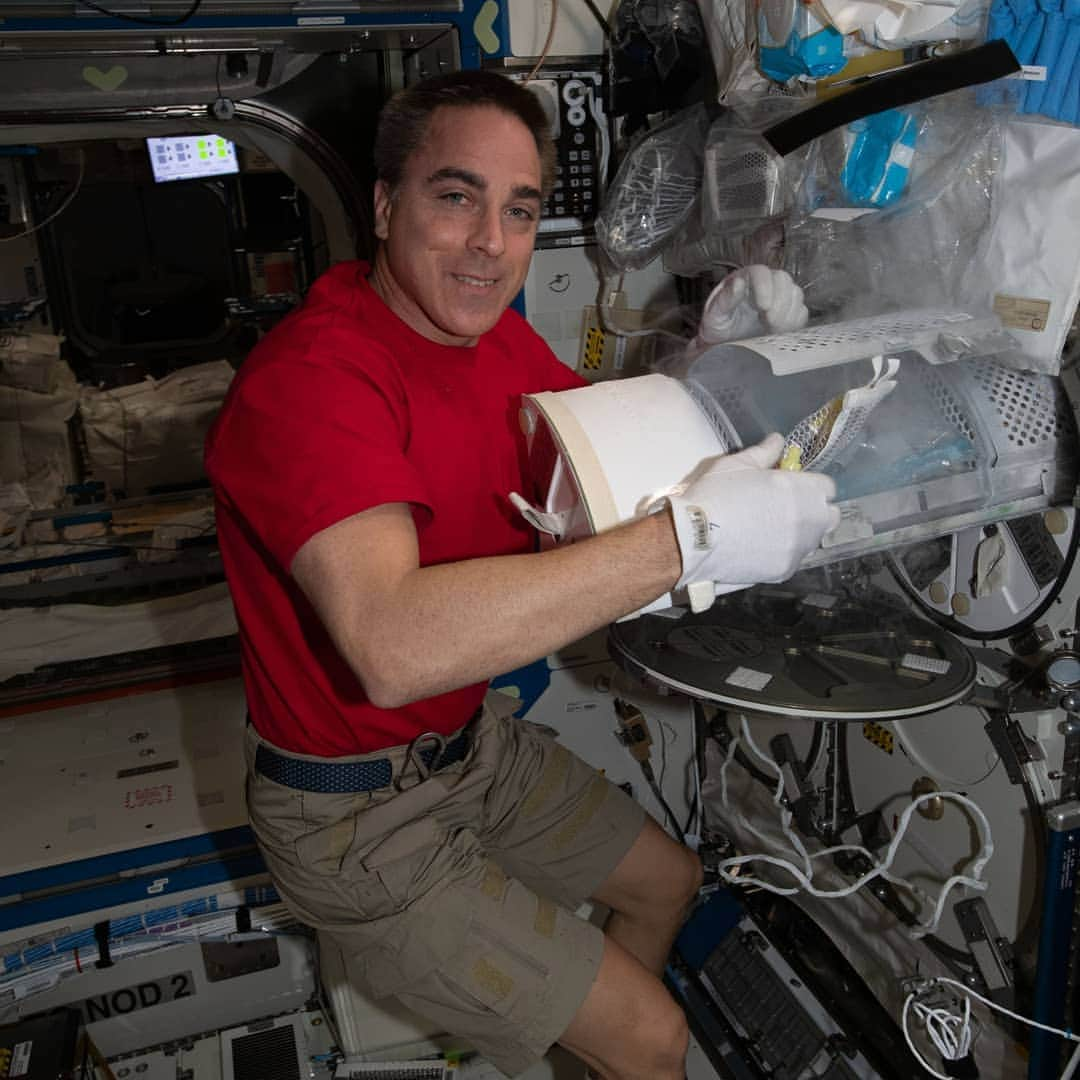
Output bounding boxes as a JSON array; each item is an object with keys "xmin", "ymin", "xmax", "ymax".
[{"xmin": 206, "ymin": 262, "xmax": 584, "ymax": 757}]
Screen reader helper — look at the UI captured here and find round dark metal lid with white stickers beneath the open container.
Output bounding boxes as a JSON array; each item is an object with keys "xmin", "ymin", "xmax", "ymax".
[{"xmin": 609, "ymin": 585, "xmax": 975, "ymax": 720}]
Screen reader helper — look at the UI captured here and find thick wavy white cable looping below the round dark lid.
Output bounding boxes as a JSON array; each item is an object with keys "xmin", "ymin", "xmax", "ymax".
[{"xmin": 717, "ymin": 715, "xmax": 994, "ymax": 937}]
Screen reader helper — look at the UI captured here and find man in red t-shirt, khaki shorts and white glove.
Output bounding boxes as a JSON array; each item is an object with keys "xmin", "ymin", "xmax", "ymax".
[{"xmin": 206, "ymin": 71, "xmax": 836, "ymax": 1080}]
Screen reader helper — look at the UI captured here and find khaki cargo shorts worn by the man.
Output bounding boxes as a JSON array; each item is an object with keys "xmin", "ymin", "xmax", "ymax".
[{"xmin": 247, "ymin": 693, "xmax": 645, "ymax": 1076}]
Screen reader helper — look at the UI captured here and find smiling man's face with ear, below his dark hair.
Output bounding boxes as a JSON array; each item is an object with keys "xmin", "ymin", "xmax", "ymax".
[{"xmin": 372, "ymin": 106, "xmax": 540, "ymax": 346}]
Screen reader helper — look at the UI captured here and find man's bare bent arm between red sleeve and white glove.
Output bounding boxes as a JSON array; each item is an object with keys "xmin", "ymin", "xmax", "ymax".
[{"xmin": 292, "ymin": 503, "xmax": 681, "ymax": 708}]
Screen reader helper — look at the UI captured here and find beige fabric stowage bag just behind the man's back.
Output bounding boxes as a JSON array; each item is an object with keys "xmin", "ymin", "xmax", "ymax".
[{"xmin": 79, "ymin": 360, "xmax": 233, "ymax": 495}]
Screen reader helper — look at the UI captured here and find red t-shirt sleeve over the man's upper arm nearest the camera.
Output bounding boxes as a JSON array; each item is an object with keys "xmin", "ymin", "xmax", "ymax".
[{"xmin": 206, "ymin": 361, "xmax": 430, "ymax": 571}]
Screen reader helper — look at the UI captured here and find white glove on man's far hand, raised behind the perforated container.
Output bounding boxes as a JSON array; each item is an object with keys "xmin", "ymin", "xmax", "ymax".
[{"xmin": 698, "ymin": 266, "xmax": 809, "ymax": 345}]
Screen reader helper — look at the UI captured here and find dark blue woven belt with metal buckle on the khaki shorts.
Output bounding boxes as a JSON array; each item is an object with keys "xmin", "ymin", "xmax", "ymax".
[{"xmin": 255, "ymin": 731, "xmax": 469, "ymax": 794}]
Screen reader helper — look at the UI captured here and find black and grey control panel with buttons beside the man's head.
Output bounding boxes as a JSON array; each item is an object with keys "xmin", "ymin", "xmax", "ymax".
[{"xmin": 516, "ymin": 71, "xmax": 608, "ymax": 243}]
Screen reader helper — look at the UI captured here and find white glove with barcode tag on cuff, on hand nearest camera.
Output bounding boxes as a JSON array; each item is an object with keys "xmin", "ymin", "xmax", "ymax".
[{"xmin": 649, "ymin": 434, "xmax": 840, "ymax": 611}]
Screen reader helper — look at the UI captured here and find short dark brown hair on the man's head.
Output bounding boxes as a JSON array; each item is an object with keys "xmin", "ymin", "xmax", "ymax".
[{"xmin": 375, "ymin": 70, "xmax": 555, "ymax": 194}]
